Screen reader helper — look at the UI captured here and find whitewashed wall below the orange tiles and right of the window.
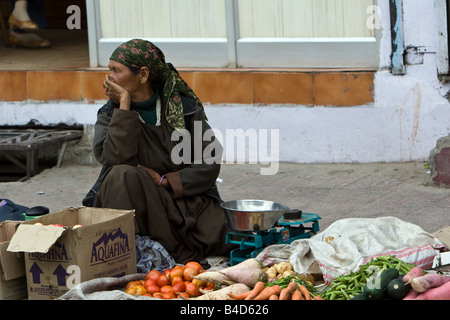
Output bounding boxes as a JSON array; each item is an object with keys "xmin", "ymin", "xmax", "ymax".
[{"xmin": 0, "ymin": 0, "xmax": 450, "ymax": 163}]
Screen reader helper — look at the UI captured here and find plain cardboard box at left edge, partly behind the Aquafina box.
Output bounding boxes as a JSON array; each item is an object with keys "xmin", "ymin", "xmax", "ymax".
[{"xmin": 0, "ymin": 221, "xmax": 27, "ymax": 300}]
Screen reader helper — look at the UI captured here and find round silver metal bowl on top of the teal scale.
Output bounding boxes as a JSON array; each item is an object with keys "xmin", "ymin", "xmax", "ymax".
[{"xmin": 221, "ymin": 200, "xmax": 289, "ymax": 231}]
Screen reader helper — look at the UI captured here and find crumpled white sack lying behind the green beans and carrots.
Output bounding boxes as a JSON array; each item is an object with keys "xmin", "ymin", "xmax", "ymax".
[{"xmin": 256, "ymin": 217, "xmax": 446, "ymax": 283}]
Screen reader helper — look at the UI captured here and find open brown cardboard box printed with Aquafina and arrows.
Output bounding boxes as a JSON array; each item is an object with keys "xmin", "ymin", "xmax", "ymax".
[{"xmin": 8, "ymin": 207, "xmax": 137, "ymax": 300}]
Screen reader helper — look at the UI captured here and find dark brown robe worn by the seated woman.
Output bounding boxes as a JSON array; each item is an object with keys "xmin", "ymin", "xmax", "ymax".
[{"xmin": 94, "ymin": 98, "xmax": 230, "ymax": 263}]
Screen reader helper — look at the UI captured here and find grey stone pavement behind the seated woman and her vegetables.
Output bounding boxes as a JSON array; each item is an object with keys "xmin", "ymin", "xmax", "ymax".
[{"xmin": 0, "ymin": 162, "xmax": 450, "ymax": 233}]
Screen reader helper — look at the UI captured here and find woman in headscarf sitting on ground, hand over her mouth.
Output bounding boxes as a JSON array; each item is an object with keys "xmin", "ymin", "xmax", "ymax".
[{"xmin": 90, "ymin": 39, "xmax": 229, "ymax": 263}]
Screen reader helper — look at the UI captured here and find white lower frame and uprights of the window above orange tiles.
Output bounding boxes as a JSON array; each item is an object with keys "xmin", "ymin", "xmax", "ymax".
[{"xmin": 87, "ymin": 0, "xmax": 380, "ymax": 69}]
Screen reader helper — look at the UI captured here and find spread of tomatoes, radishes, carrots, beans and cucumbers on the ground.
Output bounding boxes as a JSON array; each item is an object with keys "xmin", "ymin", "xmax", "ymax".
[{"xmin": 126, "ymin": 256, "xmax": 450, "ymax": 300}]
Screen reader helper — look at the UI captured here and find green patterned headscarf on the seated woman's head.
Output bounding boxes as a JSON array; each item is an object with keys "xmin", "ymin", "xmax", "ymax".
[{"xmin": 110, "ymin": 39, "xmax": 204, "ymax": 131}]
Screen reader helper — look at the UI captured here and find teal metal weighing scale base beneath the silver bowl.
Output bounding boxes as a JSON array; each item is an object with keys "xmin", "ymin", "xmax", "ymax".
[{"xmin": 222, "ymin": 200, "xmax": 321, "ymax": 265}]
